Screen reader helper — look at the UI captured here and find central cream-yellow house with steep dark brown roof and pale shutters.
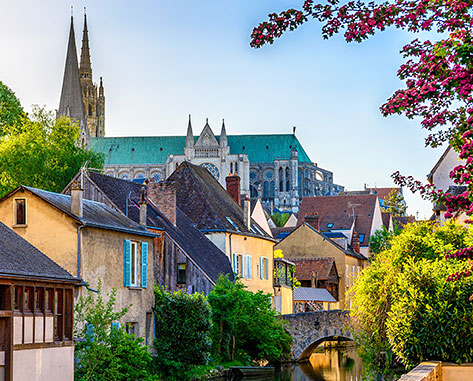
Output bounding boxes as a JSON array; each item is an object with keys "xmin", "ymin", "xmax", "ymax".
[{"xmin": 167, "ymin": 162, "xmax": 275, "ymax": 295}]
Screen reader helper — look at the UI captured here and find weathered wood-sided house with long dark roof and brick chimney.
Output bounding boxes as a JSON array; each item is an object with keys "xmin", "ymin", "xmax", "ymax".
[{"xmin": 63, "ymin": 170, "xmax": 233, "ymax": 295}]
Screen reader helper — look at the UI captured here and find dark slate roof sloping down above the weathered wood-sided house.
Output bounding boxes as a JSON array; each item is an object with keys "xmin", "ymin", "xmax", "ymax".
[{"xmin": 87, "ymin": 171, "xmax": 233, "ymax": 282}]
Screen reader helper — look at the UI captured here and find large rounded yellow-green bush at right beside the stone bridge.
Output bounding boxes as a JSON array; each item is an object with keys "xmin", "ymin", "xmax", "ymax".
[{"xmin": 351, "ymin": 222, "xmax": 473, "ymax": 367}]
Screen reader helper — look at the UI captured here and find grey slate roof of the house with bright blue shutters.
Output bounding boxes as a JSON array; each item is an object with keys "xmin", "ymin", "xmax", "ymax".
[{"xmin": 23, "ymin": 186, "xmax": 155, "ymax": 237}]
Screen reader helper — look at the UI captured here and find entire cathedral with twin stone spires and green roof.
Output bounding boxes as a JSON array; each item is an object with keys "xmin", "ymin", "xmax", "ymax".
[{"xmin": 57, "ymin": 15, "xmax": 344, "ymax": 212}]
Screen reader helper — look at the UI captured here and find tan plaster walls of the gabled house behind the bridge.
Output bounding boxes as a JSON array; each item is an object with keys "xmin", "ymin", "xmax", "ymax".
[{"xmin": 275, "ymin": 223, "xmax": 368, "ymax": 309}]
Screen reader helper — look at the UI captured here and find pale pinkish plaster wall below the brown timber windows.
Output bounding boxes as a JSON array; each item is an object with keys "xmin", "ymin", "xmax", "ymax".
[{"xmin": 13, "ymin": 345, "xmax": 74, "ymax": 381}]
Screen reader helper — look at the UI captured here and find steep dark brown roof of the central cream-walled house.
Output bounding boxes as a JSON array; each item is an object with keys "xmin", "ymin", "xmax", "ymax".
[{"xmin": 168, "ymin": 161, "xmax": 272, "ymax": 240}]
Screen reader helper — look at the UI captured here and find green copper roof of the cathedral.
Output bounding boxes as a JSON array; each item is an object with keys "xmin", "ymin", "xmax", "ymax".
[{"xmin": 90, "ymin": 134, "xmax": 310, "ymax": 164}]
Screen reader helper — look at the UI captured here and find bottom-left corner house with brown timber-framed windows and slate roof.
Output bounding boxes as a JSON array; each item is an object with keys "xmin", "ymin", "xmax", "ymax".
[{"xmin": 0, "ymin": 222, "xmax": 81, "ymax": 381}]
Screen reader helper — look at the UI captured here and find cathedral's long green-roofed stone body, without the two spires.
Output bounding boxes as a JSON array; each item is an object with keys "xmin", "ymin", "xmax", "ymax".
[{"xmin": 90, "ymin": 117, "xmax": 343, "ymax": 212}]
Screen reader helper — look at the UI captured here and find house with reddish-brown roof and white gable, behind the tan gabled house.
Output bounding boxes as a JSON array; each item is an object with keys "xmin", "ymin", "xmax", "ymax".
[{"xmin": 297, "ymin": 194, "xmax": 383, "ymax": 255}]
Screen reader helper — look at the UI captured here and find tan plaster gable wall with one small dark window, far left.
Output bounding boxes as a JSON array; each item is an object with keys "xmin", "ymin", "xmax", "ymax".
[{"xmin": 0, "ymin": 191, "xmax": 77, "ymax": 276}]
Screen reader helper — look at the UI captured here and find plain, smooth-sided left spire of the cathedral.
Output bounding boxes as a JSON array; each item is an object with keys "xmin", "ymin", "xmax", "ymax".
[{"xmin": 57, "ymin": 15, "xmax": 89, "ymax": 137}]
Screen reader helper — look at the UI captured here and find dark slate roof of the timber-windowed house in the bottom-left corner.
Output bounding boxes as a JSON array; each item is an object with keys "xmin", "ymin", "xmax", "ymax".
[{"xmin": 0, "ymin": 222, "xmax": 80, "ymax": 283}]
